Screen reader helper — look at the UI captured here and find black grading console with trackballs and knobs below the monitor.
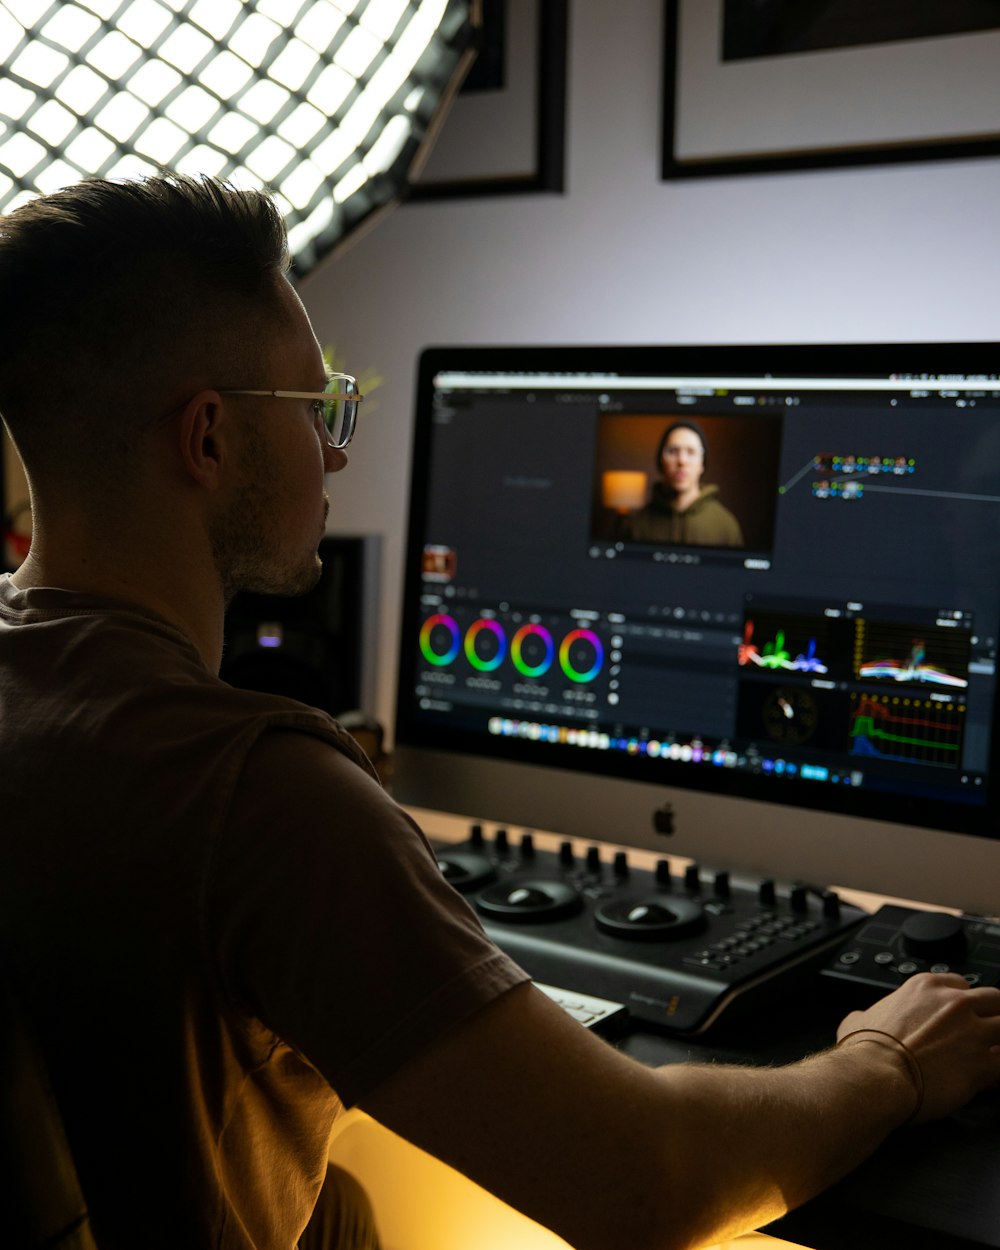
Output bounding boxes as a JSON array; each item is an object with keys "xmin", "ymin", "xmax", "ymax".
[{"xmin": 438, "ymin": 825, "xmax": 865, "ymax": 1034}]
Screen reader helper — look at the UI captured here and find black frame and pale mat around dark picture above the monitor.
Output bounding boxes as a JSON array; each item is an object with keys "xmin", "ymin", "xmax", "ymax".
[{"xmin": 661, "ymin": 0, "xmax": 1000, "ymax": 180}]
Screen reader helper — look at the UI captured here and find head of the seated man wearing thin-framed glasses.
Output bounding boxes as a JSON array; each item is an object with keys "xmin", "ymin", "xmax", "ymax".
[{"xmin": 0, "ymin": 175, "xmax": 346, "ymax": 598}]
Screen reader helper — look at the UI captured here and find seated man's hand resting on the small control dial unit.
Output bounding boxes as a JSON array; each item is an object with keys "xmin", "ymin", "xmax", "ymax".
[{"xmin": 838, "ymin": 973, "xmax": 1000, "ymax": 1123}]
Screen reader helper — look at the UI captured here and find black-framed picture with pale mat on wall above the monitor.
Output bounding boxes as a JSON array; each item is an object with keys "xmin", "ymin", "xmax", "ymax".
[{"xmin": 663, "ymin": 0, "xmax": 1000, "ymax": 179}]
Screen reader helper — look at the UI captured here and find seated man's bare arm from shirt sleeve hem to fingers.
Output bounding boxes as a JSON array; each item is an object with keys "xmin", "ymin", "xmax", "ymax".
[{"xmin": 363, "ymin": 975, "xmax": 1000, "ymax": 1250}]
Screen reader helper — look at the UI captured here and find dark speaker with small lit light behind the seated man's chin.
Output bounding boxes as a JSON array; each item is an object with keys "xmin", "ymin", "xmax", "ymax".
[{"xmin": 219, "ymin": 535, "xmax": 379, "ymax": 716}]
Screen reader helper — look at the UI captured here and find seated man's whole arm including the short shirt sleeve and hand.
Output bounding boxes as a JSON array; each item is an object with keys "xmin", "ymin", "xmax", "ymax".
[{"xmin": 218, "ymin": 733, "xmax": 1000, "ymax": 1250}]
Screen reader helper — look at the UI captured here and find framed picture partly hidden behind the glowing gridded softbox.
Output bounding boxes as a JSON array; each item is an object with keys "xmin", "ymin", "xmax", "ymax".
[{"xmin": 409, "ymin": 0, "xmax": 568, "ymax": 200}]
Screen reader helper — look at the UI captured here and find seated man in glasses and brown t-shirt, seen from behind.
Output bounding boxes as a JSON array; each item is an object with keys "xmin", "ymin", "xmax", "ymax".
[{"xmin": 0, "ymin": 178, "xmax": 1000, "ymax": 1250}]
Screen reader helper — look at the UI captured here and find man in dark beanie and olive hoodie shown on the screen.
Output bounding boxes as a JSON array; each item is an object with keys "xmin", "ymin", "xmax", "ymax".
[{"xmin": 624, "ymin": 421, "xmax": 744, "ymax": 546}]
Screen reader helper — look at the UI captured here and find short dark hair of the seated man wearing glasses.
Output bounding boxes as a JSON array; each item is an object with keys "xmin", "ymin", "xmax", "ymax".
[{"xmin": 0, "ymin": 174, "xmax": 289, "ymax": 480}]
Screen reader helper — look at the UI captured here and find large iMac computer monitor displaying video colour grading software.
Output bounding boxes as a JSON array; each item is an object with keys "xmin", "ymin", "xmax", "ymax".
[{"xmin": 394, "ymin": 344, "xmax": 1000, "ymax": 913}]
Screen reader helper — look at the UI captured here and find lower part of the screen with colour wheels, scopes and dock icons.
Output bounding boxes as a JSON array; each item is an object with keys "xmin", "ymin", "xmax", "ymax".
[{"xmin": 416, "ymin": 593, "xmax": 995, "ymax": 794}]
